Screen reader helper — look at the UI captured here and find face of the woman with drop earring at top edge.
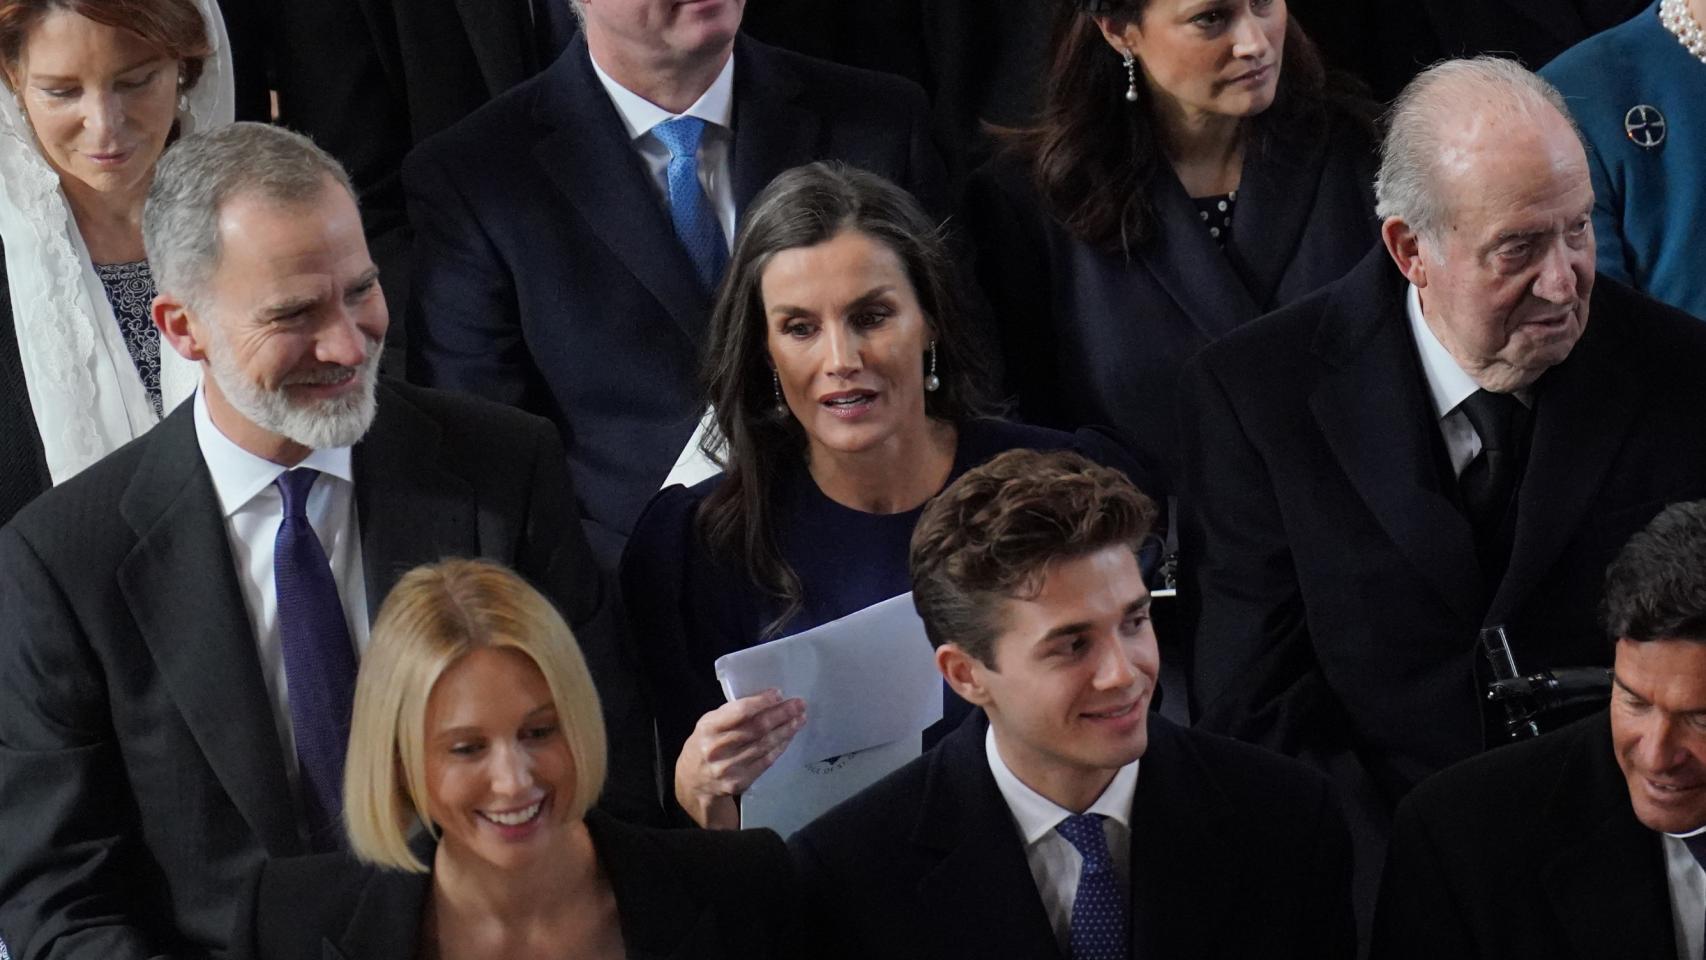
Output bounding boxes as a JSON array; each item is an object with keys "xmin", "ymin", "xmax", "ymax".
[{"xmin": 1102, "ymin": 0, "xmax": 1286, "ymax": 125}]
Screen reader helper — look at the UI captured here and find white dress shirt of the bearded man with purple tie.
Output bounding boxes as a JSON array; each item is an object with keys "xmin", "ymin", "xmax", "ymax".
[{"xmin": 194, "ymin": 390, "xmax": 367, "ymax": 789}]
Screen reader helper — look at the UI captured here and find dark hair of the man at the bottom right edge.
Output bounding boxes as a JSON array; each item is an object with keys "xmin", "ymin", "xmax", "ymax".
[{"xmin": 1600, "ymin": 500, "xmax": 1706, "ymax": 643}]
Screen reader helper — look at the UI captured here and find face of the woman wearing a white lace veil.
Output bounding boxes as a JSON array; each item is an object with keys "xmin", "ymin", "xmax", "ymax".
[{"xmin": 12, "ymin": 10, "xmax": 179, "ymax": 201}]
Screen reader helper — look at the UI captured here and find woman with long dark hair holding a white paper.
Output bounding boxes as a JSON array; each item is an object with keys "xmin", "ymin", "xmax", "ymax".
[{"xmin": 623, "ymin": 164, "xmax": 1121, "ymax": 827}]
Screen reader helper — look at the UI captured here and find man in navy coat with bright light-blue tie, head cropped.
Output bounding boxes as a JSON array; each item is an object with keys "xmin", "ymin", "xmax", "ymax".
[{"xmin": 403, "ymin": 0, "xmax": 947, "ymax": 570}]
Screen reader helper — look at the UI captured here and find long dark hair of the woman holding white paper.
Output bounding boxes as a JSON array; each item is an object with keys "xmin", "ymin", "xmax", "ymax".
[{"xmin": 696, "ymin": 164, "xmax": 989, "ymax": 634}]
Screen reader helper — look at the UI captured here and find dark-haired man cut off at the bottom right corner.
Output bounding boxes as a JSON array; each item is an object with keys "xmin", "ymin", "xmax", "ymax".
[{"xmin": 1372, "ymin": 500, "xmax": 1706, "ymax": 960}]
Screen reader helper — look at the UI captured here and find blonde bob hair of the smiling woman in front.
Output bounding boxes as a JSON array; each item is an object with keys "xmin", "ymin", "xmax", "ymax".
[{"xmin": 343, "ymin": 559, "xmax": 606, "ymax": 873}]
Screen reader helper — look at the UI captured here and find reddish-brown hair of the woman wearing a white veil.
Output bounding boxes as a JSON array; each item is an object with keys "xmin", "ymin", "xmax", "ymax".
[{"xmin": 0, "ymin": 0, "xmax": 213, "ymax": 90}]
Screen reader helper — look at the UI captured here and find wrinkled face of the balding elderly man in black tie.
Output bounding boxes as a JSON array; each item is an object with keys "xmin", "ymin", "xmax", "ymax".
[{"xmin": 1411, "ymin": 111, "xmax": 1593, "ymax": 392}]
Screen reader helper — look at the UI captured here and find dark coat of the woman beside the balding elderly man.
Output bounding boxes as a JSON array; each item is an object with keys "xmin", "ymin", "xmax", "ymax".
[{"xmin": 964, "ymin": 107, "xmax": 1377, "ymax": 496}]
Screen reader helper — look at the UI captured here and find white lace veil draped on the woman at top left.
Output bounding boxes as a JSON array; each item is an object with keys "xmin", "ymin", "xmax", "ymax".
[{"xmin": 0, "ymin": 0, "xmax": 235, "ymax": 484}]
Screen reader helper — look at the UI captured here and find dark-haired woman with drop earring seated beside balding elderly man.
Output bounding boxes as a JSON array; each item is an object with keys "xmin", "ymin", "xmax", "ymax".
[{"xmin": 962, "ymin": 0, "xmax": 1377, "ymax": 496}]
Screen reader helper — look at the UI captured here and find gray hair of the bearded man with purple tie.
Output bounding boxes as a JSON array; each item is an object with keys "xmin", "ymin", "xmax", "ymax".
[{"xmin": 142, "ymin": 123, "xmax": 355, "ymax": 298}]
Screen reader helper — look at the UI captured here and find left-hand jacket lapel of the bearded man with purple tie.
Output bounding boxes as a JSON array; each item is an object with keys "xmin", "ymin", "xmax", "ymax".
[{"xmin": 118, "ymin": 404, "xmax": 302, "ymax": 856}]
